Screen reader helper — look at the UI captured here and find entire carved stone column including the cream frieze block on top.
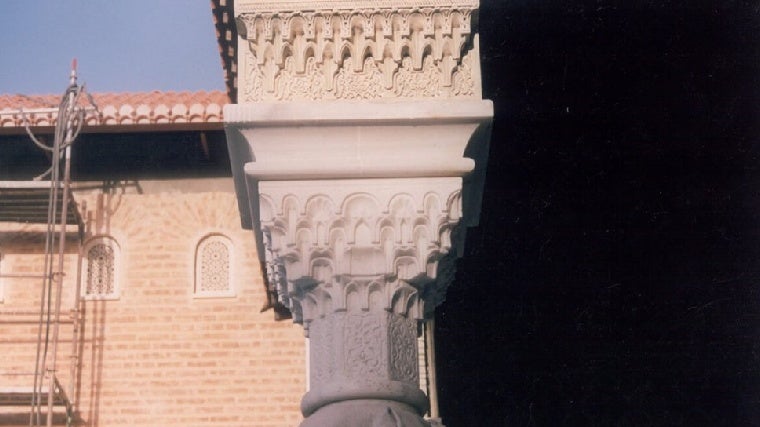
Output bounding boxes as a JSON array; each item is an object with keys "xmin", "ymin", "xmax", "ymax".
[{"xmin": 224, "ymin": 0, "xmax": 493, "ymax": 427}]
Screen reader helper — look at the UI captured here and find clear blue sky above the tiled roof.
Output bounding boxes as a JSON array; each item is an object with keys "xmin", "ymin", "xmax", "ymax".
[{"xmin": 0, "ymin": 0, "xmax": 224, "ymax": 95}]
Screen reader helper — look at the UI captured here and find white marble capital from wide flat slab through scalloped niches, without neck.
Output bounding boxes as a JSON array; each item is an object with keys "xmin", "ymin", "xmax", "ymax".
[{"xmin": 225, "ymin": 100, "xmax": 492, "ymax": 320}]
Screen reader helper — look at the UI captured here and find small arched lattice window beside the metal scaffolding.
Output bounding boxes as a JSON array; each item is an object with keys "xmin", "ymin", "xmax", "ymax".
[{"xmin": 82, "ymin": 236, "xmax": 119, "ymax": 299}]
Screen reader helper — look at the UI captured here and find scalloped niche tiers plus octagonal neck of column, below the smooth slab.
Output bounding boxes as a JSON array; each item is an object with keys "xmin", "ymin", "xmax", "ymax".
[{"xmin": 259, "ymin": 178, "xmax": 461, "ymax": 426}]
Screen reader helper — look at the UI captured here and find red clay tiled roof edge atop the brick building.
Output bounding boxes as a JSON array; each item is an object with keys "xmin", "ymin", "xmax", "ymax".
[{"xmin": 0, "ymin": 91, "xmax": 230, "ymax": 128}]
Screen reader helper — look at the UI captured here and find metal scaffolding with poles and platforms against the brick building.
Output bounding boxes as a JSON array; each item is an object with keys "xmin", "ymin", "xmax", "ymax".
[{"xmin": 0, "ymin": 61, "xmax": 97, "ymax": 427}]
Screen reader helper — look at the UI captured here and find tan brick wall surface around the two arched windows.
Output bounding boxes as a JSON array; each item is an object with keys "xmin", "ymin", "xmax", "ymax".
[{"xmin": 0, "ymin": 181, "xmax": 306, "ymax": 426}]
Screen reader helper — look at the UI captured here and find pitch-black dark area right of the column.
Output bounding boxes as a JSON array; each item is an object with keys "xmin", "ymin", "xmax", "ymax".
[{"xmin": 436, "ymin": 0, "xmax": 760, "ymax": 427}]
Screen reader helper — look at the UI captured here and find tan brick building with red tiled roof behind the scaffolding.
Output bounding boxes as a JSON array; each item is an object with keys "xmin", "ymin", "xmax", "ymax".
[{"xmin": 0, "ymin": 92, "xmax": 306, "ymax": 426}]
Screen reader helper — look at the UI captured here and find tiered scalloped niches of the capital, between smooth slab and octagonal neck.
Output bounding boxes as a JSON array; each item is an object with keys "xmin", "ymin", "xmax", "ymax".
[{"xmin": 260, "ymin": 178, "xmax": 461, "ymax": 334}]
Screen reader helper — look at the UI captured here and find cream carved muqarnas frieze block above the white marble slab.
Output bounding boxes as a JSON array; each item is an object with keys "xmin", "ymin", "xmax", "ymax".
[{"xmin": 237, "ymin": 7, "xmax": 479, "ymax": 102}]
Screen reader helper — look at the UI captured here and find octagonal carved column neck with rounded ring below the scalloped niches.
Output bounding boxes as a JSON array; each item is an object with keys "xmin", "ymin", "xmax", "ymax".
[{"xmin": 301, "ymin": 308, "xmax": 427, "ymax": 427}]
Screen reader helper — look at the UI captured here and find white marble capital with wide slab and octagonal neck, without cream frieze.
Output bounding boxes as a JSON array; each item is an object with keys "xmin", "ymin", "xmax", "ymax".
[{"xmin": 224, "ymin": 100, "xmax": 492, "ymax": 426}]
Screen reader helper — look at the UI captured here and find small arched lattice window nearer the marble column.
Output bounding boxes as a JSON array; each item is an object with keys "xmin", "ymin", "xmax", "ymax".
[{"xmin": 193, "ymin": 234, "xmax": 235, "ymax": 297}]
